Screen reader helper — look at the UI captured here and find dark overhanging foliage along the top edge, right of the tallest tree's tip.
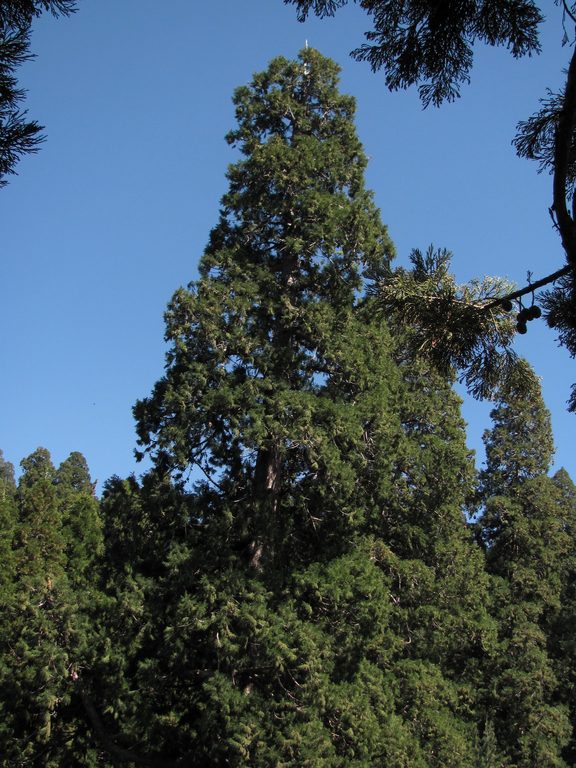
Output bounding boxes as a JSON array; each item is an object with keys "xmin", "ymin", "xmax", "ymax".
[{"xmin": 284, "ymin": 0, "xmax": 543, "ymax": 105}]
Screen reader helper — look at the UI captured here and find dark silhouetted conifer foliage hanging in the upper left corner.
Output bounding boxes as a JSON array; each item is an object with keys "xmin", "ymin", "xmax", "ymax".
[{"xmin": 0, "ymin": 0, "xmax": 76, "ymax": 187}]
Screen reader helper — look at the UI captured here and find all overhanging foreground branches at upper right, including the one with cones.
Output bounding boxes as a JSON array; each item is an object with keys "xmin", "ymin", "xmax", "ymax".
[{"xmin": 284, "ymin": 0, "xmax": 576, "ymax": 411}]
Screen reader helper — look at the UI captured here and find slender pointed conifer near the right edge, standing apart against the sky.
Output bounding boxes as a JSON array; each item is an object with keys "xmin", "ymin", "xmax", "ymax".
[{"xmin": 480, "ymin": 364, "xmax": 570, "ymax": 768}]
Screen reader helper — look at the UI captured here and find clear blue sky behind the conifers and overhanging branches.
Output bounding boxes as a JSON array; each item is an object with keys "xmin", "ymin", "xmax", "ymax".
[{"xmin": 0, "ymin": 0, "xmax": 576, "ymax": 488}]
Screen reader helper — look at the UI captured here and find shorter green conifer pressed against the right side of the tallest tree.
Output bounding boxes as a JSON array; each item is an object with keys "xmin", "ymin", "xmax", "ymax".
[{"xmin": 376, "ymin": 352, "xmax": 496, "ymax": 766}]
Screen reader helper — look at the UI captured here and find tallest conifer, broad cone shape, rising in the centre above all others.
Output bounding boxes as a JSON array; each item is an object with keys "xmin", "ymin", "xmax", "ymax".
[{"xmin": 95, "ymin": 50, "xmax": 415, "ymax": 766}]
